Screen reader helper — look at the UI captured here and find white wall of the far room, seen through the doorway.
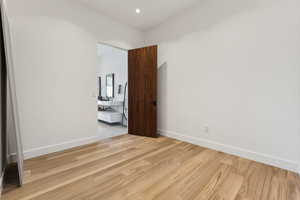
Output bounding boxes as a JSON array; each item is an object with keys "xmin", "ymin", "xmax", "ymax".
[{"xmin": 97, "ymin": 44, "xmax": 128, "ymax": 101}]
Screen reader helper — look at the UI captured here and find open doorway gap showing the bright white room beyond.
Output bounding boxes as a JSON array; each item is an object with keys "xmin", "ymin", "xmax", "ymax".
[{"xmin": 96, "ymin": 43, "xmax": 128, "ymax": 138}]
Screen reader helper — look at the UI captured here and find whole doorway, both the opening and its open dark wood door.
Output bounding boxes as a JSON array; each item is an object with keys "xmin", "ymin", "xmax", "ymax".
[{"xmin": 97, "ymin": 43, "xmax": 158, "ymax": 138}]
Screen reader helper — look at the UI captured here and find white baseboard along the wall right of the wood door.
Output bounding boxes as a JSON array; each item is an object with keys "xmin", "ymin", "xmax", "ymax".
[{"xmin": 158, "ymin": 130, "xmax": 300, "ymax": 173}]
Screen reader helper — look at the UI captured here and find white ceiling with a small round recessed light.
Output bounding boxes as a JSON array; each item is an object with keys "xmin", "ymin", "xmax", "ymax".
[{"xmin": 78, "ymin": 0, "xmax": 199, "ymax": 31}]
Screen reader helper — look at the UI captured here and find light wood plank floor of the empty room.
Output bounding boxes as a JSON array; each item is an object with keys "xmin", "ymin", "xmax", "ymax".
[{"xmin": 3, "ymin": 135, "xmax": 300, "ymax": 200}]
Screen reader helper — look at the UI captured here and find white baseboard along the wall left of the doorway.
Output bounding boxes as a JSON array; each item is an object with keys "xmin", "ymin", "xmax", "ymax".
[{"xmin": 10, "ymin": 136, "xmax": 103, "ymax": 162}]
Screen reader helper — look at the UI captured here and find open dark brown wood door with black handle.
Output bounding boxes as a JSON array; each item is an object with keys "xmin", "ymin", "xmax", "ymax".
[{"xmin": 128, "ymin": 46, "xmax": 157, "ymax": 137}]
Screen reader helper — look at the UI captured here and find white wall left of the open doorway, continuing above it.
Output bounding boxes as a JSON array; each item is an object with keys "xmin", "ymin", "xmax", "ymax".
[{"xmin": 8, "ymin": 0, "xmax": 143, "ymax": 158}]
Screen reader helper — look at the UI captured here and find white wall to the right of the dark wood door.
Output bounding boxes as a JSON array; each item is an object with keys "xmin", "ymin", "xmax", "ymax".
[{"xmin": 147, "ymin": 0, "xmax": 300, "ymax": 171}]
